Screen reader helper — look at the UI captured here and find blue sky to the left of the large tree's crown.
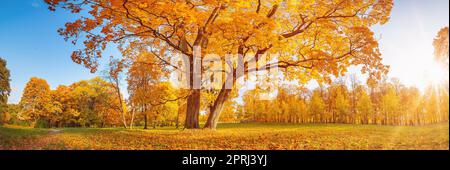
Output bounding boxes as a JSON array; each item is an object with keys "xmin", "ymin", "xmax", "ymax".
[{"xmin": 0, "ymin": 0, "xmax": 121, "ymax": 103}]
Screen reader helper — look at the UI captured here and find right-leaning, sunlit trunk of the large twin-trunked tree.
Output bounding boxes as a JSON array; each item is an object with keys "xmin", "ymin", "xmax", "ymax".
[{"xmin": 204, "ymin": 86, "xmax": 231, "ymax": 129}]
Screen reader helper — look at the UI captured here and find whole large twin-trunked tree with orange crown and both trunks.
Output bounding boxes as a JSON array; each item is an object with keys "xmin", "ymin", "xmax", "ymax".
[{"xmin": 46, "ymin": 0, "xmax": 393, "ymax": 128}]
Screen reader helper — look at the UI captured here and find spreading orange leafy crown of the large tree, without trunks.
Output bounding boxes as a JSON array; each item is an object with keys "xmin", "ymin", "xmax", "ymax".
[{"xmin": 47, "ymin": 0, "xmax": 393, "ymax": 87}]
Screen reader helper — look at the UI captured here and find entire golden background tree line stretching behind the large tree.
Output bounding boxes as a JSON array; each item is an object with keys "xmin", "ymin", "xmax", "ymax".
[{"xmin": 0, "ymin": 58, "xmax": 449, "ymax": 129}]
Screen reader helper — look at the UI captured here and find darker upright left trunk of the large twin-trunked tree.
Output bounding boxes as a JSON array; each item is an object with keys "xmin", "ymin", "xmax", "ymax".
[{"xmin": 184, "ymin": 89, "xmax": 200, "ymax": 129}]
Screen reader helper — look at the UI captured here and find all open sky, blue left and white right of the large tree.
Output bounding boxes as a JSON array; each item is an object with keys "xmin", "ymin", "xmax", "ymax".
[{"xmin": 0, "ymin": 0, "xmax": 449, "ymax": 103}]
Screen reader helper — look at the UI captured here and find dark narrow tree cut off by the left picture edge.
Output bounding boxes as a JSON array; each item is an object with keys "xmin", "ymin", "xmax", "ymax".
[{"xmin": 0, "ymin": 58, "xmax": 11, "ymax": 124}]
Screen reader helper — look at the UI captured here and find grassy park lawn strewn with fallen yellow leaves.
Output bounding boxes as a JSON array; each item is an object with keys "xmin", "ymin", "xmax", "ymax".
[{"xmin": 0, "ymin": 123, "xmax": 449, "ymax": 150}]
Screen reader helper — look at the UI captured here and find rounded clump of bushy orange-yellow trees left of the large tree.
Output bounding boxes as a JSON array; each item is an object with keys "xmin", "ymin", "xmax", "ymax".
[{"xmin": 18, "ymin": 78, "xmax": 125, "ymax": 127}]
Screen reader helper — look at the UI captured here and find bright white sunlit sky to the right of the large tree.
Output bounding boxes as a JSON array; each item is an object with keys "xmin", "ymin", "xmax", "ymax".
[{"xmin": 374, "ymin": 0, "xmax": 449, "ymax": 90}]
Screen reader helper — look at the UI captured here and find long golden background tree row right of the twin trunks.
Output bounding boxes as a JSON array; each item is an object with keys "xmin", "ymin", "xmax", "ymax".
[{"xmin": 236, "ymin": 79, "xmax": 449, "ymax": 125}]
